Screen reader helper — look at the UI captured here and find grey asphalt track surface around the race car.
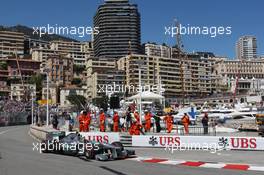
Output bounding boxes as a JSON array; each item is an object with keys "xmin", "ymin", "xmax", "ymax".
[{"xmin": 0, "ymin": 126, "xmax": 264, "ymax": 175}]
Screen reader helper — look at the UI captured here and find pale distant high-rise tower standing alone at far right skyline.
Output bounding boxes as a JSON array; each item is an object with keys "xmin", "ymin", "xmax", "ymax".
[{"xmin": 236, "ymin": 36, "xmax": 257, "ymax": 60}]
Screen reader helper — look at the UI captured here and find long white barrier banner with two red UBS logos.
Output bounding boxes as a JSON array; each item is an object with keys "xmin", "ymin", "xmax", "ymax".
[{"xmin": 132, "ymin": 135, "xmax": 264, "ymax": 150}]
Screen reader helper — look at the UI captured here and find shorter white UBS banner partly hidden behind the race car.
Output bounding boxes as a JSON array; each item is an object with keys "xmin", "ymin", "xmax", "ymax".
[{"xmin": 66, "ymin": 132, "xmax": 120, "ymax": 143}]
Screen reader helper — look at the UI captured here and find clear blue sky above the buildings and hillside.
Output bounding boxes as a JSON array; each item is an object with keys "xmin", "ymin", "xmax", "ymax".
[{"xmin": 0, "ymin": 0, "xmax": 264, "ymax": 58}]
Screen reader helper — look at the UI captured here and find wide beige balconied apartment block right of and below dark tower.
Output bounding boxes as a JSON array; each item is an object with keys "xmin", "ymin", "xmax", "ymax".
[{"xmin": 117, "ymin": 55, "xmax": 215, "ymax": 98}]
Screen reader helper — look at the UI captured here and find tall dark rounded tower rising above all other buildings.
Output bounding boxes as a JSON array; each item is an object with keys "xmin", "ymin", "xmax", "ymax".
[{"xmin": 94, "ymin": 0, "xmax": 141, "ymax": 59}]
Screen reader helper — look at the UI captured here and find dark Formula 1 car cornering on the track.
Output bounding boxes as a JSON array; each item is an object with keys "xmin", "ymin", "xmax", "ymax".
[{"xmin": 41, "ymin": 132, "xmax": 135, "ymax": 161}]
